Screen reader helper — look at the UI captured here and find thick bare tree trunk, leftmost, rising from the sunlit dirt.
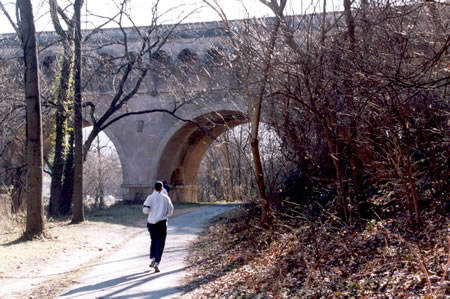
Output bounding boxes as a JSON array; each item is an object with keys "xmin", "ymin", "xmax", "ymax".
[{"xmin": 17, "ymin": 0, "xmax": 44, "ymax": 236}]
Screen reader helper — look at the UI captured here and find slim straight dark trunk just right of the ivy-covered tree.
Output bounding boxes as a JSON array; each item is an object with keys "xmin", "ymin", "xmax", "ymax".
[{"xmin": 72, "ymin": 0, "xmax": 84, "ymax": 223}]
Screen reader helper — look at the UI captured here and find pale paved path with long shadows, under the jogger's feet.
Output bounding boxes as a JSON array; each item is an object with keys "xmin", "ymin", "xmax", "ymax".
[{"xmin": 59, "ymin": 206, "xmax": 231, "ymax": 299}]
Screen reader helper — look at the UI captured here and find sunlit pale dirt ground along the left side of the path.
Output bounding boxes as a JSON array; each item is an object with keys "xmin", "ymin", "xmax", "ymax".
[{"xmin": 0, "ymin": 207, "xmax": 200, "ymax": 298}]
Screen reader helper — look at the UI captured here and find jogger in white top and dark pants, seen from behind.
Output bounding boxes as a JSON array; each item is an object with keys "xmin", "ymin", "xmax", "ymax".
[{"xmin": 142, "ymin": 181, "xmax": 173, "ymax": 272}]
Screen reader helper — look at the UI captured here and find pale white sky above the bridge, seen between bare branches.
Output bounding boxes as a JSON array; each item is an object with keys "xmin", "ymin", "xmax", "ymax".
[{"xmin": 0, "ymin": 0, "xmax": 341, "ymax": 33}]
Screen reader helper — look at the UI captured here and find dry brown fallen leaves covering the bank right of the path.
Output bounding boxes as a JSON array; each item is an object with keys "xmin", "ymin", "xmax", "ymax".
[{"xmin": 181, "ymin": 204, "xmax": 450, "ymax": 298}]
